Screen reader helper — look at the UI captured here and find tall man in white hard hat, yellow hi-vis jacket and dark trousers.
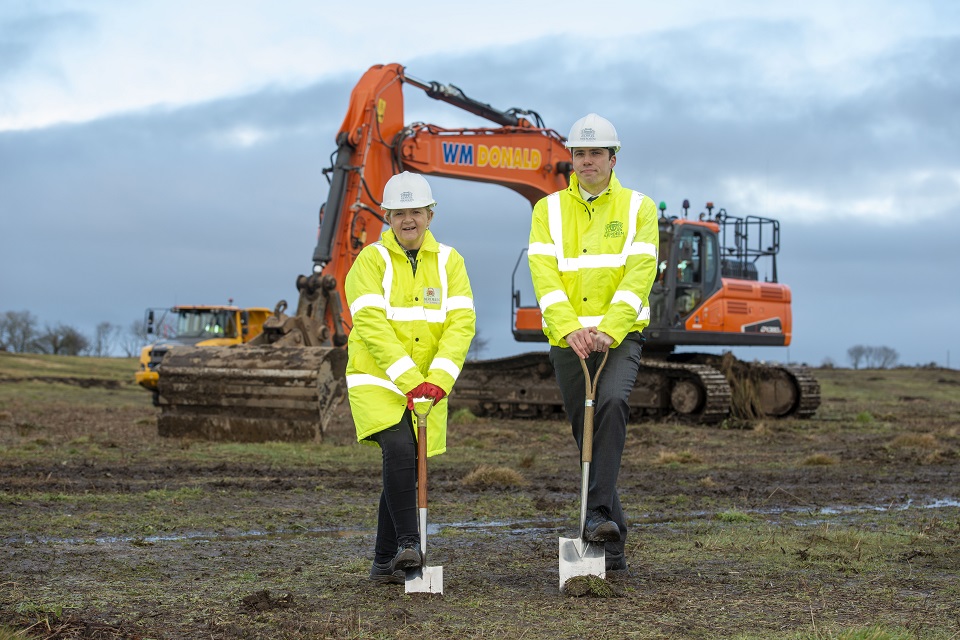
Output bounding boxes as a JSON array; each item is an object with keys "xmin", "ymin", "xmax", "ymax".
[{"xmin": 528, "ymin": 113, "xmax": 660, "ymax": 571}]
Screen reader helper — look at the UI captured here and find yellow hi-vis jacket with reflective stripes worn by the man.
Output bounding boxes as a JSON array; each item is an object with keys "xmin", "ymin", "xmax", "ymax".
[{"xmin": 527, "ymin": 174, "xmax": 660, "ymax": 347}]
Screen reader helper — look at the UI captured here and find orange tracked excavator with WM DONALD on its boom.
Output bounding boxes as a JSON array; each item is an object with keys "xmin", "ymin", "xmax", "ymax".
[{"xmin": 159, "ymin": 64, "xmax": 819, "ymax": 441}]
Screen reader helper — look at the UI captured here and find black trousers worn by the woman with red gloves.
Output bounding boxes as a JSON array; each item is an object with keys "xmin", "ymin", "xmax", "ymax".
[{"xmin": 370, "ymin": 410, "xmax": 420, "ymax": 564}]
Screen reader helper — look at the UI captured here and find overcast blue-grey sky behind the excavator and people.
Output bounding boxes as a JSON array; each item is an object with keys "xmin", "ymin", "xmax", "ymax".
[{"xmin": 0, "ymin": 0, "xmax": 960, "ymax": 368}]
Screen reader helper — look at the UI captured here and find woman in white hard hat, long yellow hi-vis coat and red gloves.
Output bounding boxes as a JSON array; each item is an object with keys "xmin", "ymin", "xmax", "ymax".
[{"xmin": 345, "ymin": 171, "xmax": 476, "ymax": 584}]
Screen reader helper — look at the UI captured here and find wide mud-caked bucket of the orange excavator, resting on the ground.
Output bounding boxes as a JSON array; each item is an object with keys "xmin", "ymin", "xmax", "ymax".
[{"xmin": 158, "ymin": 345, "xmax": 347, "ymax": 442}]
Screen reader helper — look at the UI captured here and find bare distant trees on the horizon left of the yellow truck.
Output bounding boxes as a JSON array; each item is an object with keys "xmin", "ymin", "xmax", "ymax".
[{"xmin": 0, "ymin": 311, "xmax": 148, "ymax": 358}]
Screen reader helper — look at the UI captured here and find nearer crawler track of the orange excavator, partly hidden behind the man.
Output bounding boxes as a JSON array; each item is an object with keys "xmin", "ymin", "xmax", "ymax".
[{"xmin": 450, "ymin": 352, "xmax": 730, "ymax": 424}]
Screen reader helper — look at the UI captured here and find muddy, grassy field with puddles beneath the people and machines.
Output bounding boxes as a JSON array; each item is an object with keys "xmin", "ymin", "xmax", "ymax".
[{"xmin": 0, "ymin": 360, "xmax": 960, "ymax": 639}]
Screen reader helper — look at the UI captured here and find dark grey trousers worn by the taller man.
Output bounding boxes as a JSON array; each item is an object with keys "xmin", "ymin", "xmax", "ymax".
[{"xmin": 550, "ymin": 331, "xmax": 643, "ymax": 555}]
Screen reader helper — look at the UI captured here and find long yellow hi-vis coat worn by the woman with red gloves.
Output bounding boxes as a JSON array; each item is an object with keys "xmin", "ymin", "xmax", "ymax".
[{"xmin": 345, "ymin": 229, "xmax": 477, "ymax": 456}]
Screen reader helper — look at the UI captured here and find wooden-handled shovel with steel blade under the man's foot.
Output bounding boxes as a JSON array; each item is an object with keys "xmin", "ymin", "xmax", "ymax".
[{"xmin": 560, "ymin": 351, "xmax": 610, "ymax": 591}]
